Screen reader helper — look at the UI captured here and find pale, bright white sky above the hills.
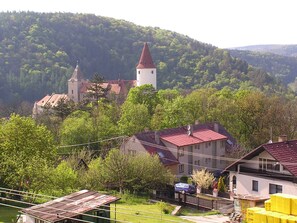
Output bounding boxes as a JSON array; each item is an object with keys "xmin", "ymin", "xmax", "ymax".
[{"xmin": 0, "ymin": 0, "xmax": 297, "ymax": 48}]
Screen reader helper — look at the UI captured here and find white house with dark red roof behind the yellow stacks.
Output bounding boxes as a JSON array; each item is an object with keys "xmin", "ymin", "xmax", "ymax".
[{"xmin": 226, "ymin": 136, "xmax": 297, "ymax": 198}]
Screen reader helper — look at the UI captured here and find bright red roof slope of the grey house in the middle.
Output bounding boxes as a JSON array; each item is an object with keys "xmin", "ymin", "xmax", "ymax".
[{"xmin": 161, "ymin": 129, "xmax": 227, "ymax": 146}]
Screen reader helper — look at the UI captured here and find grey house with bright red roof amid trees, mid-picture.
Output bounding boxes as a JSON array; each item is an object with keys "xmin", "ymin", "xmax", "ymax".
[{"xmin": 121, "ymin": 123, "xmax": 235, "ymax": 177}]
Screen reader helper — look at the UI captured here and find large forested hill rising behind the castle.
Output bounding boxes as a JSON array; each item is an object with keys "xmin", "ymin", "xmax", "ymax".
[{"xmin": 0, "ymin": 12, "xmax": 279, "ymax": 102}]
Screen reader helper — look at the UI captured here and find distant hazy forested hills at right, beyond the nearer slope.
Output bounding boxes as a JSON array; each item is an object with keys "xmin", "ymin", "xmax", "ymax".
[{"xmin": 230, "ymin": 49, "xmax": 297, "ymax": 91}]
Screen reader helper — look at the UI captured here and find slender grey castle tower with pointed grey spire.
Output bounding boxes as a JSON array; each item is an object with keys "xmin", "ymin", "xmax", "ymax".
[{"xmin": 68, "ymin": 63, "xmax": 87, "ymax": 103}]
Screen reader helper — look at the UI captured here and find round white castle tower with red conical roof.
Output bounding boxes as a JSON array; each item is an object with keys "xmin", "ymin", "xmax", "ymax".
[{"xmin": 136, "ymin": 43, "xmax": 157, "ymax": 89}]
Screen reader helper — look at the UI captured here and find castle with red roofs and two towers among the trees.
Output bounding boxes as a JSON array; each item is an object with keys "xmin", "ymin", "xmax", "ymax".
[{"xmin": 33, "ymin": 43, "xmax": 157, "ymax": 117}]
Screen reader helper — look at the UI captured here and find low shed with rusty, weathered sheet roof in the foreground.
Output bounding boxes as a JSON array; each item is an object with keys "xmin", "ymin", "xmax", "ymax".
[{"xmin": 18, "ymin": 190, "xmax": 120, "ymax": 223}]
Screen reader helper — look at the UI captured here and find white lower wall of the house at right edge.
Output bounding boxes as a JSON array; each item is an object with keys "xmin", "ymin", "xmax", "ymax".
[{"xmin": 229, "ymin": 172, "xmax": 297, "ymax": 198}]
